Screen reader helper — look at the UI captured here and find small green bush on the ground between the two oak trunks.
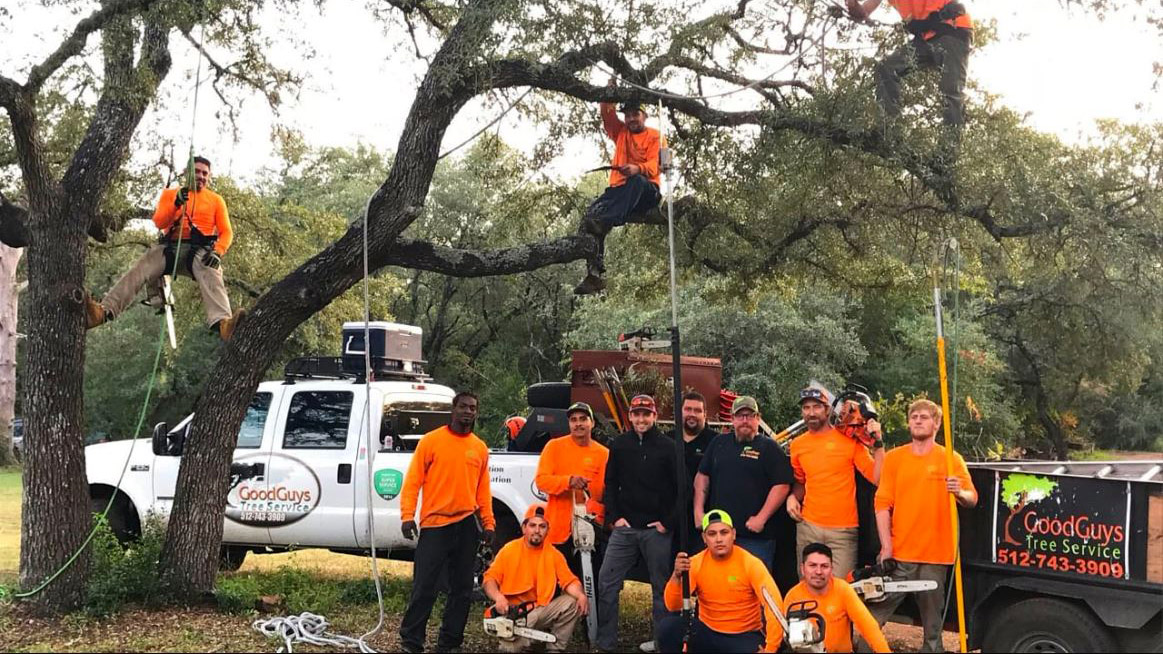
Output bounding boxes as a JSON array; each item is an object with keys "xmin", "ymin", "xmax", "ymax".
[{"xmin": 85, "ymin": 516, "xmax": 165, "ymax": 616}]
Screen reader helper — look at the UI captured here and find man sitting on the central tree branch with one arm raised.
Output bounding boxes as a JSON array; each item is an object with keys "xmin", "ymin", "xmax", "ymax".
[{"xmin": 573, "ymin": 78, "xmax": 662, "ymax": 296}]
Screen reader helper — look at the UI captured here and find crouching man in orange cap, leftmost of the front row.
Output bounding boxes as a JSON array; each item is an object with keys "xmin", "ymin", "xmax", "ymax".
[{"xmin": 481, "ymin": 503, "xmax": 590, "ymax": 652}]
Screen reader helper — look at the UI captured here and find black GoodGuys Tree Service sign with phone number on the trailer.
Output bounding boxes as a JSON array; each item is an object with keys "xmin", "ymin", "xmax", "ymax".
[{"xmin": 994, "ymin": 472, "xmax": 1130, "ymax": 577}]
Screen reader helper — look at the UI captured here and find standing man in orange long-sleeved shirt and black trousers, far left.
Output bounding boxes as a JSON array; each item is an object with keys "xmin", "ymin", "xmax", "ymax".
[{"xmin": 400, "ymin": 391, "xmax": 497, "ymax": 652}]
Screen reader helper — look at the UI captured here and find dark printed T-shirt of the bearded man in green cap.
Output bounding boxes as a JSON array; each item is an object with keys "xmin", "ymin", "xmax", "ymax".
[{"xmin": 699, "ymin": 433, "xmax": 794, "ymax": 539}]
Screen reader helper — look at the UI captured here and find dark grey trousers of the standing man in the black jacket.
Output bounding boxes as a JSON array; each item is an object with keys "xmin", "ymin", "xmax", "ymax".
[{"xmin": 597, "ymin": 527, "xmax": 675, "ymax": 651}]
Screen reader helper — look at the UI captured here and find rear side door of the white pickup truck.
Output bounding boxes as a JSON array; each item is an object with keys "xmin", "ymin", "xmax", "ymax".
[{"xmin": 267, "ymin": 384, "xmax": 363, "ymax": 547}]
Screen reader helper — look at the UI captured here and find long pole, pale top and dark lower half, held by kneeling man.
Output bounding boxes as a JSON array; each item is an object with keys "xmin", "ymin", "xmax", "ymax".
[{"xmin": 658, "ymin": 100, "xmax": 691, "ymax": 619}]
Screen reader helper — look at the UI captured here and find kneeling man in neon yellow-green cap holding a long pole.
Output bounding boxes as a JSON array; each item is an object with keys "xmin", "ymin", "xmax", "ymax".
[{"xmin": 658, "ymin": 509, "xmax": 784, "ymax": 652}]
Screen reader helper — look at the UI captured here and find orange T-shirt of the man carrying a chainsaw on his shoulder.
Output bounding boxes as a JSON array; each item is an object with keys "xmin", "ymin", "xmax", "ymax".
[{"xmin": 791, "ymin": 427, "xmax": 876, "ymax": 529}]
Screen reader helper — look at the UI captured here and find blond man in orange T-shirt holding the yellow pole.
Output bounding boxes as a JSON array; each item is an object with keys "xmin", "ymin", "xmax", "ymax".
[{"xmin": 871, "ymin": 399, "xmax": 977, "ymax": 652}]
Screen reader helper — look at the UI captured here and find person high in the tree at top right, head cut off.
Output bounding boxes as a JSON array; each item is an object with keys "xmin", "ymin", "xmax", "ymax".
[{"xmin": 847, "ymin": 0, "xmax": 973, "ymax": 138}]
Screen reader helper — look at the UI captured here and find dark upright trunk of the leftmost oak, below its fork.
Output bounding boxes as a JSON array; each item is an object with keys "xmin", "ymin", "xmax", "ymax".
[{"xmin": 20, "ymin": 189, "xmax": 92, "ymax": 613}]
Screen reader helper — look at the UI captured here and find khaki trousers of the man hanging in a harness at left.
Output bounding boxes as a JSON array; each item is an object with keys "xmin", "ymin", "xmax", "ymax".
[{"xmin": 101, "ymin": 246, "xmax": 230, "ymax": 327}]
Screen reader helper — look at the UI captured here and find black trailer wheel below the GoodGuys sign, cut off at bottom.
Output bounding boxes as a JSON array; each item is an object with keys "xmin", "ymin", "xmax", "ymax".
[{"xmin": 982, "ymin": 597, "xmax": 1118, "ymax": 652}]
